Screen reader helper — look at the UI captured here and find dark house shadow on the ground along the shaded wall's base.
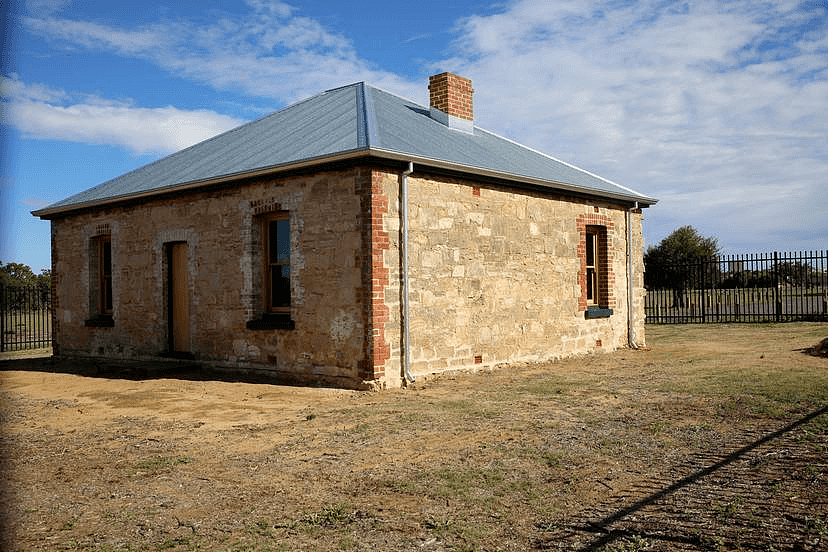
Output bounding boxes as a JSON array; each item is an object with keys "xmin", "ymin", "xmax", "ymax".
[{"xmin": 0, "ymin": 356, "xmax": 334, "ymax": 387}]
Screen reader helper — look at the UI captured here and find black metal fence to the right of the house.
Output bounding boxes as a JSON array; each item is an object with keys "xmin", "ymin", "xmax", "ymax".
[{"xmin": 644, "ymin": 251, "xmax": 828, "ymax": 324}]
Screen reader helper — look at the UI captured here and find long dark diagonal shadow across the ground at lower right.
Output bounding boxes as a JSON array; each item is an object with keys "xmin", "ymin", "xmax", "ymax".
[{"xmin": 544, "ymin": 406, "xmax": 828, "ymax": 552}]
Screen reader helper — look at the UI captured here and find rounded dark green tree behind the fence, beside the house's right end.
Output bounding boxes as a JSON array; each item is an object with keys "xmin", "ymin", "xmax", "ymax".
[{"xmin": 644, "ymin": 226, "xmax": 719, "ymax": 308}]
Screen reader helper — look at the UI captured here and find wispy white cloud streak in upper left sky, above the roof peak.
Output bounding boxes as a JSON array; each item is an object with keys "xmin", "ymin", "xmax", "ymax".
[{"xmin": 25, "ymin": 0, "xmax": 423, "ymax": 103}]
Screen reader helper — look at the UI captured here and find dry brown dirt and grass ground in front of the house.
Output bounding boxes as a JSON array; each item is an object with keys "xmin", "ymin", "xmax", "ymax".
[{"xmin": 0, "ymin": 323, "xmax": 828, "ymax": 552}]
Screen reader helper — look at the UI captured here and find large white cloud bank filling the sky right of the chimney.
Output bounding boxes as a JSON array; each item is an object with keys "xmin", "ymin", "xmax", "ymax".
[{"xmin": 440, "ymin": 0, "xmax": 828, "ymax": 253}]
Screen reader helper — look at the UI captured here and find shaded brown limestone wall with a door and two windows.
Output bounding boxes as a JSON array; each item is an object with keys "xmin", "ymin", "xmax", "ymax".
[{"xmin": 52, "ymin": 168, "xmax": 374, "ymax": 385}]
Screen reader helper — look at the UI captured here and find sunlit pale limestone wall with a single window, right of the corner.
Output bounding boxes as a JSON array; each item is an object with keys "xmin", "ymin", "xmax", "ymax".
[{"xmin": 382, "ymin": 172, "xmax": 644, "ymax": 385}]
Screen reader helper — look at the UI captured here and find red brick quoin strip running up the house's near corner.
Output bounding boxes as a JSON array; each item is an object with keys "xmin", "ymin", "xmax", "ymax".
[{"xmin": 370, "ymin": 171, "xmax": 391, "ymax": 379}]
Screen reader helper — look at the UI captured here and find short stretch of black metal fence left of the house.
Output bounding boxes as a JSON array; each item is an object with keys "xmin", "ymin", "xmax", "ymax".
[{"xmin": 0, "ymin": 284, "xmax": 52, "ymax": 353}]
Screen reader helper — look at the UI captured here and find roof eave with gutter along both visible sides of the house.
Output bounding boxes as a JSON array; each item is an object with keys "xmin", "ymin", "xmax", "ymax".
[{"xmin": 32, "ymin": 147, "xmax": 658, "ymax": 220}]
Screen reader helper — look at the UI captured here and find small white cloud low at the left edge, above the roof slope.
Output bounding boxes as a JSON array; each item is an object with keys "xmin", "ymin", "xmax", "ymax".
[{"xmin": 2, "ymin": 79, "xmax": 243, "ymax": 154}]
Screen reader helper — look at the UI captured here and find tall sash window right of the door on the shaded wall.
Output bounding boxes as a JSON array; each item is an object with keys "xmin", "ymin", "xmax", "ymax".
[{"xmin": 263, "ymin": 211, "xmax": 290, "ymax": 313}]
